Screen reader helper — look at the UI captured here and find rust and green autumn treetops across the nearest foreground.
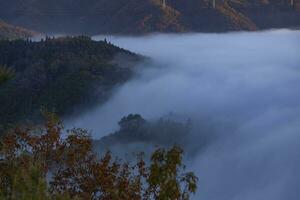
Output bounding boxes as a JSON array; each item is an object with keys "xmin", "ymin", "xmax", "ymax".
[{"xmin": 0, "ymin": 113, "xmax": 198, "ymax": 200}]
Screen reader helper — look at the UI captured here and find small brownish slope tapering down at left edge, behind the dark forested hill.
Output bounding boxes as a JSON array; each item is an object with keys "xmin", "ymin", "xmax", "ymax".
[{"xmin": 0, "ymin": 20, "xmax": 37, "ymax": 39}]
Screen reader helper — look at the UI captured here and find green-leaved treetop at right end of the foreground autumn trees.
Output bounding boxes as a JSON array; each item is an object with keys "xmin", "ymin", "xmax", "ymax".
[{"xmin": 147, "ymin": 146, "xmax": 197, "ymax": 200}]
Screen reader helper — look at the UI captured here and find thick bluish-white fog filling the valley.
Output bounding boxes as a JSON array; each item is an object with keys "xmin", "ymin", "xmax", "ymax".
[{"xmin": 67, "ymin": 30, "xmax": 300, "ymax": 200}]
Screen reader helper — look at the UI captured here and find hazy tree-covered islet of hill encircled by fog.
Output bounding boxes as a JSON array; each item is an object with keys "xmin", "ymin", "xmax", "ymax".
[{"xmin": 94, "ymin": 114, "xmax": 191, "ymax": 150}]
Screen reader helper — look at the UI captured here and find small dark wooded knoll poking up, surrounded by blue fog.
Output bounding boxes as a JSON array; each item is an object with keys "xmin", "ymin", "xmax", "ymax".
[{"xmin": 93, "ymin": 114, "xmax": 206, "ymax": 158}]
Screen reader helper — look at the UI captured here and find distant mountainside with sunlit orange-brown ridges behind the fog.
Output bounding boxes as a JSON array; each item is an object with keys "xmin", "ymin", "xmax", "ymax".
[{"xmin": 0, "ymin": 0, "xmax": 300, "ymax": 34}]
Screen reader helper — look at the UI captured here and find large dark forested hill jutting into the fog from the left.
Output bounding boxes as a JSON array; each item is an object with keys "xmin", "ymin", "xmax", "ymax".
[{"xmin": 0, "ymin": 36, "xmax": 142, "ymax": 132}]
